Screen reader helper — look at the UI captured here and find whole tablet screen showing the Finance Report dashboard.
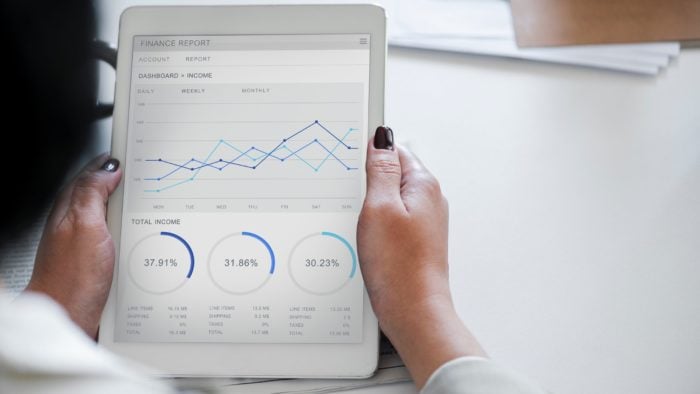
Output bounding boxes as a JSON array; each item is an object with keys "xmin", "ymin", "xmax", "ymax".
[{"xmin": 115, "ymin": 34, "xmax": 370, "ymax": 343}]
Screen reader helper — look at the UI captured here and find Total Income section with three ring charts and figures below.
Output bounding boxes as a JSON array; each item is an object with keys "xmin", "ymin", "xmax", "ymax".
[{"xmin": 117, "ymin": 213, "xmax": 363, "ymax": 343}]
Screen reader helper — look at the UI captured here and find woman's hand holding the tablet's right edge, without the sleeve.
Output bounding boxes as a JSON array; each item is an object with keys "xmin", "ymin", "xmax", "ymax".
[{"xmin": 357, "ymin": 127, "xmax": 485, "ymax": 388}]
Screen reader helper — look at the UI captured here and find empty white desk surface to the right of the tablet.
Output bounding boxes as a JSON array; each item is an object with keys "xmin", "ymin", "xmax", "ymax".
[{"xmin": 94, "ymin": 1, "xmax": 700, "ymax": 394}]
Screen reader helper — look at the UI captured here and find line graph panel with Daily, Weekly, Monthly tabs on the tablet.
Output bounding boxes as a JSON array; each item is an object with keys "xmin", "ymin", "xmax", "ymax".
[{"xmin": 126, "ymin": 82, "xmax": 367, "ymax": 212}]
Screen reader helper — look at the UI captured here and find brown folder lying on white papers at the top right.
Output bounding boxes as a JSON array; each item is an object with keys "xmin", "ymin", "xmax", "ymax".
[{"xmin": 511, "ymin": 0, "xmax": 700, "ymax": 47}]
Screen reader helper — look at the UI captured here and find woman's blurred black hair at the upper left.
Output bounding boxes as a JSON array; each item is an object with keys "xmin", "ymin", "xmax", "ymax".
[{"xmin": 0, "ymin": 0, "xmax": 96, "ymax": 244}]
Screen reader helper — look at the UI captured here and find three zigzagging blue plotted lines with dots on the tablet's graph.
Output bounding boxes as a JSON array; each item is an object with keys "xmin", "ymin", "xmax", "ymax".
[{"xmin": 144, "ymin": 120, "xmax": 359, "ymax": 193}]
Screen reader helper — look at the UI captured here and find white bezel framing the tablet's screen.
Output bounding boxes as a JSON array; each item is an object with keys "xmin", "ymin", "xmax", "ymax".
[{"xmin": 99, "ymin": 4, "xmax": 386, "ymax": 378}]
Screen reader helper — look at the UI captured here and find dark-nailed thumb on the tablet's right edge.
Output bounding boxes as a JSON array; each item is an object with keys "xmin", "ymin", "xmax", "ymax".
[{"xmin": 367, "ymin": 126, "xmax": 401, "ymax": 208}]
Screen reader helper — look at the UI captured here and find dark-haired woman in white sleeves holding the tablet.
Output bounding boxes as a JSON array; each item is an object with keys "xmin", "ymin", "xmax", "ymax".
[{"xmin": 0, "ymin": 1, "xmax": 542, "ymax": 393}]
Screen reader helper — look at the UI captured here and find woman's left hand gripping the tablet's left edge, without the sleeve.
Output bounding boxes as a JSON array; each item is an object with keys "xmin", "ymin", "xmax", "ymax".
[{"xmin": 27, "ymin": 155, "xmax": 122, "ymax": 338}]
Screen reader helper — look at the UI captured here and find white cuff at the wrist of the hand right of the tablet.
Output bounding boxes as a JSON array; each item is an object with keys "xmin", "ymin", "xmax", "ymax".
[{"xmin": 421, "ymin": 357, "xmax": 546, "ymax": 394}]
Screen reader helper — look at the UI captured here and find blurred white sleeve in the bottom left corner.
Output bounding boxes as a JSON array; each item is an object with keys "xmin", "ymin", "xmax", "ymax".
[{"xmin": 0, "ymin": 293, "xmax": 175, "ymax": 394}]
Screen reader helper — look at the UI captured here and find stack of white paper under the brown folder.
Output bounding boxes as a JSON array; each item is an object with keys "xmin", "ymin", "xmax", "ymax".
[{"xmin": 381, "ymin": 0, "xmax": 680, "ymax": 75}]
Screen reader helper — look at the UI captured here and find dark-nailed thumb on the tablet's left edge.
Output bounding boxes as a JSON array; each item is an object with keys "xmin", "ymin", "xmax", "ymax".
[{"xmin": 49, "ymin": 154, "xmax": 122, "ymax": 223}]
